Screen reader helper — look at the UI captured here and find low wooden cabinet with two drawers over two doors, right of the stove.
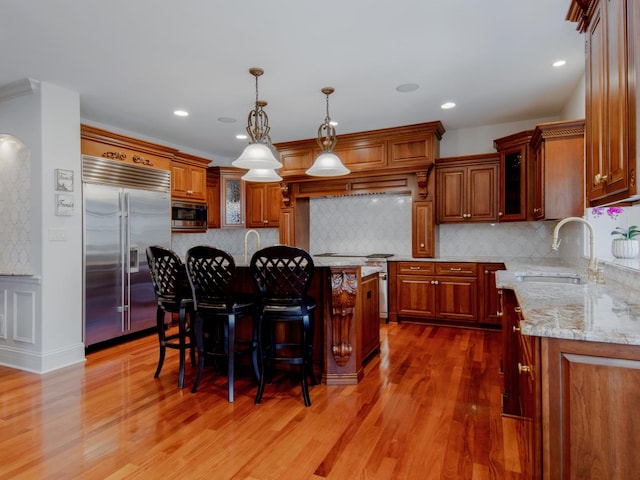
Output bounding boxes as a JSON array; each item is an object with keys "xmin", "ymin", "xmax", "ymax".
[{"xmin": 389, "ymin": 262, "xmax": 478, "ymax": 323}]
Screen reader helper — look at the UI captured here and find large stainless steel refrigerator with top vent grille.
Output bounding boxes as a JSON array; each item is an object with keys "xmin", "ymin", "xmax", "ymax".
[{"xmin": 82, "ymin": 155, "xmax": 171, "ymax": 346}]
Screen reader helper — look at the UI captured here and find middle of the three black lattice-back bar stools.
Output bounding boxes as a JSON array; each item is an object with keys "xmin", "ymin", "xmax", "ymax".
[{"xmin": 185, "ymin": 245, "xmax": 258, "ymax": 402}]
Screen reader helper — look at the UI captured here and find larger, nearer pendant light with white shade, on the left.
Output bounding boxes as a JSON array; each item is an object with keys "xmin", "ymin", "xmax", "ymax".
[{"xmin": 231, "ymin": 67, "xmax": 282, "ymax": 173}]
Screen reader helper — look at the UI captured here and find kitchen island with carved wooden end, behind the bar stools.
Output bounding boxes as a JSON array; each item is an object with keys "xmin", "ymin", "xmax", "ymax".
[{"xmin": 234, "ymin": 255, "xmax": 381, "ymax": 385}]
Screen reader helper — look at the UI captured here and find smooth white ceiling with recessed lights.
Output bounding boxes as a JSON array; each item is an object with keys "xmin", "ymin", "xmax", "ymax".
[{"xmin": 0, "ymin": 0, "xmax": 584, "ymax": 163}]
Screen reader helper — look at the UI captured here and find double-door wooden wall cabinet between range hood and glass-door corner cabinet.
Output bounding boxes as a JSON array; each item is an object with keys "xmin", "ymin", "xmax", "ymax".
[{"xmin": 436, "ymin": 155, "xmax": 500, "ymax": 223}]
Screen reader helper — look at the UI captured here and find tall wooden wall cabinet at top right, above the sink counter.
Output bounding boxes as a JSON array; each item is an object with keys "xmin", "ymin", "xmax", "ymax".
[{"xmin": 567, "ymin": 0, "xmax": 640, "ymax": 207}]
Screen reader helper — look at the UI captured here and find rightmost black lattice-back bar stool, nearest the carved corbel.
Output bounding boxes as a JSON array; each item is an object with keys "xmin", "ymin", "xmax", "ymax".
[{"xmin": 250, "ymin": 245, "xmax": 316, "ymax": 407}]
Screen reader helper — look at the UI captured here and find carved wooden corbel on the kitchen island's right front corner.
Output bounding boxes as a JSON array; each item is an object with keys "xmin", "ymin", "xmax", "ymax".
[{"xmin": 331, "ymin": 269, "xmax": 358, "ymax": 367}]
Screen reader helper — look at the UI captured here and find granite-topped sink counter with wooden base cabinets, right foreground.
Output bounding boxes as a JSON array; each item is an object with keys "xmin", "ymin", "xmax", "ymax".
[{"xmin": 497, "ymin": 261, "xmax": 640, "ymax": 479}]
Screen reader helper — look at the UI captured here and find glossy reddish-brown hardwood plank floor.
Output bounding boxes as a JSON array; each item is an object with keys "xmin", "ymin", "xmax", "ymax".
[{"xmin": 0, "ymin": 323, "xmax": 522, "ymax": 480}]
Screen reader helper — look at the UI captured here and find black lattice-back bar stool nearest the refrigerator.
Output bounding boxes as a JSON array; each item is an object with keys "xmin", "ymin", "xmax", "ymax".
[{"xmin": 146, "ymin": 245, "xmax": 195, "ymax": 388}]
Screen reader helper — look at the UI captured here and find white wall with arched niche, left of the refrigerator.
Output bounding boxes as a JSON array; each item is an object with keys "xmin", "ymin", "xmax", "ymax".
[{"xmin": 0, "ymin": 82, "xmax": 84, "ymax": 373}]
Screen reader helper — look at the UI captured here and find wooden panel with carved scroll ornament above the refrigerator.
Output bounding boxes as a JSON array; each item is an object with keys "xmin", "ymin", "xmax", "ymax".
[{"xmin": 80, "ymin": 125, "xmax": 178, "ymax": 170}]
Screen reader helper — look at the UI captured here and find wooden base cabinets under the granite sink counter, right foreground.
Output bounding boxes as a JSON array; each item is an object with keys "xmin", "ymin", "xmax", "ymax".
[{"xmin": 502, "ymin": 290, "xmax": 640, "ymax": 480}]
